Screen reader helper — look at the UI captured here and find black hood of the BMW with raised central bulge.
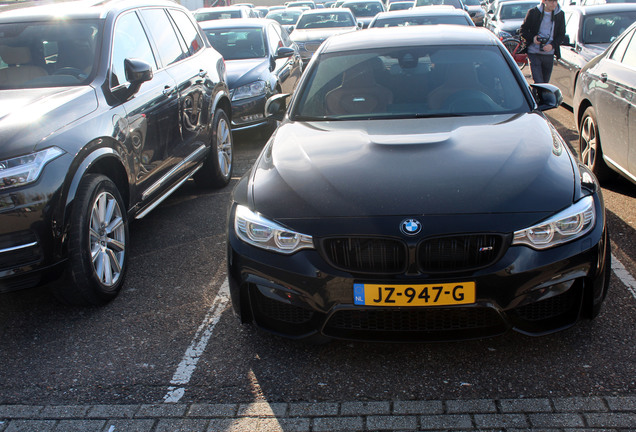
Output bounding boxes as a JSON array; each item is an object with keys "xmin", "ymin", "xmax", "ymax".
[{"xmin": 248, "ymin": 113, "xmax": 575, "ymax": 219}]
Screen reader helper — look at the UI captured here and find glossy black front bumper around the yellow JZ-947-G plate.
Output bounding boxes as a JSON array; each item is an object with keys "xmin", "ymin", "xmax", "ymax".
[{"xmin": 228, "ymin": 201, "xmax": 609, "ymax": 341}]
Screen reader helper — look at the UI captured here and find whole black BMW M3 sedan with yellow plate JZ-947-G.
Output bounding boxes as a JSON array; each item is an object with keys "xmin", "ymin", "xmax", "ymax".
[{"xmin": 228, "ymin": 26, "xmax": 610, "ymax": 342}]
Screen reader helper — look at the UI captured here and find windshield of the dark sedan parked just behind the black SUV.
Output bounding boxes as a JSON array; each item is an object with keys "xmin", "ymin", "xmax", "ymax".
[{"xmin": 203, "ymin": 28, "xmax": 267, "ymax": 60}]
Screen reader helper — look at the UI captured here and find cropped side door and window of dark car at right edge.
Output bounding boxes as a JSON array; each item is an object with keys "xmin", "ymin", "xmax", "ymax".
[{"xmin": 594, "ymin": 27, "xmax": 636, "ymax": 174}]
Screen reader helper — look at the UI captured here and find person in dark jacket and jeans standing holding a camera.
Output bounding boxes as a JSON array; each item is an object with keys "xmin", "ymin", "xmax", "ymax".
[{"xmin": 521, "ymin": 0, "xmax": 565, "ymax": 83}]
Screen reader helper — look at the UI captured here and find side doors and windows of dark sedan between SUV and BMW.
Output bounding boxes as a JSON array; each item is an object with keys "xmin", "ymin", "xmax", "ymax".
[{"xmin": 267, "ymin": 23, "xmax": 302, "ymax": 93}]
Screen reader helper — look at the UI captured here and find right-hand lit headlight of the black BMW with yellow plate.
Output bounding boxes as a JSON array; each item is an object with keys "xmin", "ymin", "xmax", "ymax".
[{"xmin": 512, "ymin": 196, "xmax": 596, "ymax": 249}]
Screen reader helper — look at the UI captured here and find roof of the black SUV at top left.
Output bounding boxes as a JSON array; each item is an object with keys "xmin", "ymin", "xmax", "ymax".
[{"xmin": 0, "ymin": 0, "xmax": 183, "ymax": 23}]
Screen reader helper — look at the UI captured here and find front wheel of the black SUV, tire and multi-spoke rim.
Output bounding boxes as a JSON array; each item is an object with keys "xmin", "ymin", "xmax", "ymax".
[{"xmin": 54, "ymin": 174, "xmax": 129, "ymax": 305}]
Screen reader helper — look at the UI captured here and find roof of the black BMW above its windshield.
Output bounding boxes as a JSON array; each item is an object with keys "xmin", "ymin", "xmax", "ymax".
[{"xmin": 322, "ymin": 24, "xmax": 498, "ymax": 53}]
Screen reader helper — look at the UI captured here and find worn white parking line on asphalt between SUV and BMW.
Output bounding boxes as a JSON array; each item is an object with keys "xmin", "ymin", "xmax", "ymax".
[{"xmin": 163, "ymin": 279, "xmax": 230, "ymax": 403}]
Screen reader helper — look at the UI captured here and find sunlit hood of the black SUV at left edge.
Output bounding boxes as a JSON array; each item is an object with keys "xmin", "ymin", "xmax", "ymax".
[{"xmin": 0, "ymin": 86, "xmax": 97, "ymax": 160}]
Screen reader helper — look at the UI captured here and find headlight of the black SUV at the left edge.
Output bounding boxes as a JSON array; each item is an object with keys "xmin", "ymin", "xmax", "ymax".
[{"xmin": 0, "ymin": 147, "xmax": 64, "ymax": 190}]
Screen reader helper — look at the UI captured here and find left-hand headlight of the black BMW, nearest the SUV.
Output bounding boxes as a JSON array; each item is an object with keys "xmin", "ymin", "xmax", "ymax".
[{"xmin": 234, "ymin": 205, "xmax": 314, "ymax": 254}]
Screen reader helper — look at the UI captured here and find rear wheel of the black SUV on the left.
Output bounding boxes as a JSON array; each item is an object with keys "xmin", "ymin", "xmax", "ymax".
[{"xmin": 194, "ymin": 108, "xmax": 234, "ymax": 188}]
